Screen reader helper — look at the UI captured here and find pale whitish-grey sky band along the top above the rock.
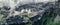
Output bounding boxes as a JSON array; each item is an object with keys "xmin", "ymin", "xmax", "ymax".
[{"xmin": 0, "ymin": 0, "xmax": 55, "ymax": 7}]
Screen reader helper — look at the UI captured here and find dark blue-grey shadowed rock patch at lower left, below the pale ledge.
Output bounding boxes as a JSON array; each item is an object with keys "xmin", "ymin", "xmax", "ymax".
[{"xmin": 6, "ymin": 15, "xmax": 23, "ymax": 24}]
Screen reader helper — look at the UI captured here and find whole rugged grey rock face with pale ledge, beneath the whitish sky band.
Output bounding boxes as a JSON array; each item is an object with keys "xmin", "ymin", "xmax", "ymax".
[{"xmin": 0, "ymin": 0, "xmax": 60, "ymax": 25}]
